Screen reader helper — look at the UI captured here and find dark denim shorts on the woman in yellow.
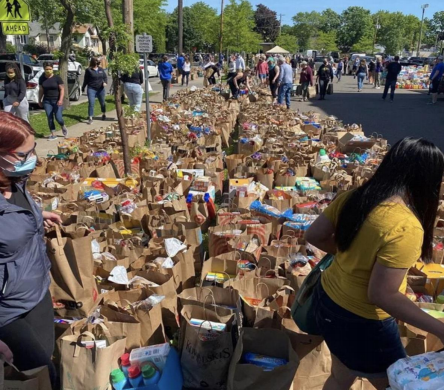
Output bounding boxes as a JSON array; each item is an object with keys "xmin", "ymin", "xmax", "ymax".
[{"xmin": 315, "ymin": 283, "xmax": 407, "ymax": 376}]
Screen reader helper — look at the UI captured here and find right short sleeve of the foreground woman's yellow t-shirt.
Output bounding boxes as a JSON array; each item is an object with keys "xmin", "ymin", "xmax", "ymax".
[{"xmin": 376, "ymin": 218, "xmax": 424, "ymax": 268}]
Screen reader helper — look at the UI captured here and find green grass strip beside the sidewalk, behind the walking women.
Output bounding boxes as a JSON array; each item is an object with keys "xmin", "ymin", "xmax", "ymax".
[{"xmin": 29, "ymin": 92, "xmax": 158, "ymax": 138}]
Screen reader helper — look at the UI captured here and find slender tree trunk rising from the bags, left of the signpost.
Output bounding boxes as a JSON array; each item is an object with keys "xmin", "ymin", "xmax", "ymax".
[{"xmin": 104, "ymin": 0, "xmax": 131, "ymax": 176}]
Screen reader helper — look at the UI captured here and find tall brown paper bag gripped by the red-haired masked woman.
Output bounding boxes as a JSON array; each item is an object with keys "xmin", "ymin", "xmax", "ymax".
[{"xmin": 47, "ymin": 226, "xmax": 99, "ymax": 317}]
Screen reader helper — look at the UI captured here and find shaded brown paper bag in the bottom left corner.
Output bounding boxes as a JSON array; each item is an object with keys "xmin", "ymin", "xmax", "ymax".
[{"xmin": 0, "ymin": 360, "xmax": 51, "ymax": 390}]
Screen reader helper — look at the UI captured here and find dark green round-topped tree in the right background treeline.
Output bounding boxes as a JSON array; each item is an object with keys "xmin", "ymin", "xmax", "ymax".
[{"xmin": 337, "ymin": 7, "xmax": 373, "ymax": 52}]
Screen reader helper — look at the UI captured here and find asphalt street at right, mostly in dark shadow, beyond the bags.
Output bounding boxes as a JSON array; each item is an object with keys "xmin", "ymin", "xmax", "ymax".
[{"xmin": 291, "ymin": 72, "xmax": 444, "ymax": 151}]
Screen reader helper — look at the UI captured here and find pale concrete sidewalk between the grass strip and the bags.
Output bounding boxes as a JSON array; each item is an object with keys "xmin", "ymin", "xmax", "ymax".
[{"xmin": 36, "ymin": 78, "xmax": 203, "ymax": 157}]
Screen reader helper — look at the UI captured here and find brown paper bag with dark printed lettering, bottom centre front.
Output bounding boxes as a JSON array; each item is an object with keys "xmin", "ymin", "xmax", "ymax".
[{"xmin": 179, "ymin": 305, "xmax": 236, "ymax": 390}]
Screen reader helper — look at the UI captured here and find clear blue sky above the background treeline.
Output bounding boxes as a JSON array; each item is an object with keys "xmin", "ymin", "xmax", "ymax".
[{"xmin": 166, "ymin": 0, "xmax": 444, "ymax": 25}]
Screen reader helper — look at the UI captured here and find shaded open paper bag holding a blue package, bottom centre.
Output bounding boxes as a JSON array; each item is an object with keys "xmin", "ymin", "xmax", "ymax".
[{"xmin": 228, "ymin": 328, "xmax": 299, "ymax": 390}]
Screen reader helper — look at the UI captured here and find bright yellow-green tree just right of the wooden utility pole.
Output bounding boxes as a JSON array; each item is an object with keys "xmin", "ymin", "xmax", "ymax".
[{"xmin": 224, "ymin": 0, "xmax": 261, "ymax": 52}]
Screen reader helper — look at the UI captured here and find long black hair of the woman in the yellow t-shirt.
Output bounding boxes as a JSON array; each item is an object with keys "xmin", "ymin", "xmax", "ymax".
[{"xmin": 335, "ymin": 138, "xmax": 444, "ymax": 261}]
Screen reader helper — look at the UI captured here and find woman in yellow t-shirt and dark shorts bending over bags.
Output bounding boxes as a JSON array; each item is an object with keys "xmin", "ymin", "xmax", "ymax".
[{"xmin": 305, "ymin": 138, "xmax": 444, "ymax": 390}]
